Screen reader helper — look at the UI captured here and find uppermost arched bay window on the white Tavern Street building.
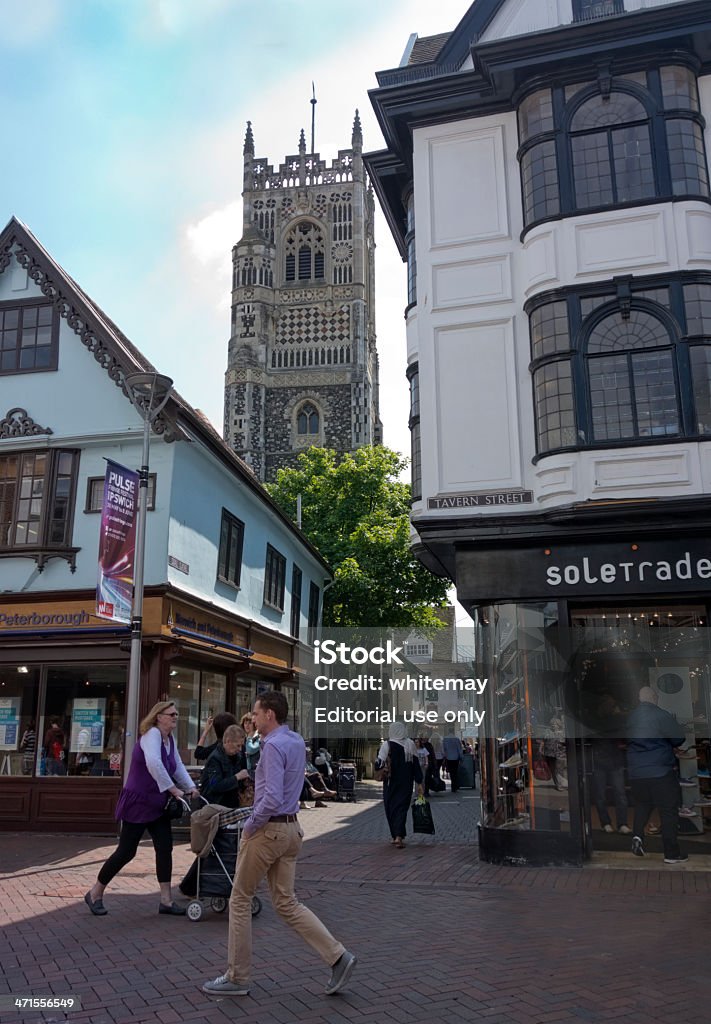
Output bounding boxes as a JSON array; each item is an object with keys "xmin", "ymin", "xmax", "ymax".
[{"xmin": 518, "ymin": 65, "xmax": 710, "ymax": 225}]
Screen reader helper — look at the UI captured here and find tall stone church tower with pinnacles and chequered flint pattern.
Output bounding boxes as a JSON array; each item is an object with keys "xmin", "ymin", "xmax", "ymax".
[{"xmin": 224, "ymin": 111, "xmax": 382, "ymax": 480}]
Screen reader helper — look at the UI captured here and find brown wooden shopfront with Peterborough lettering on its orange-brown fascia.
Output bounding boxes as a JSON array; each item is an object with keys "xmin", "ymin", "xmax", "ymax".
[{"xmin": 0, "ymin": 592, "xmax": 300, "ymax": 833}]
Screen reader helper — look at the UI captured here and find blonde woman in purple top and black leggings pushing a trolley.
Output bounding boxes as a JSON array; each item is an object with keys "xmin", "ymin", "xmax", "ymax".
[{"xmin": 84, "ymin": 700, "xmax": 198, "ymax": 916}]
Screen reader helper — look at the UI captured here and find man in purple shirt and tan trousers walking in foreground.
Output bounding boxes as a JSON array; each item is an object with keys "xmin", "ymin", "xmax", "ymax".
[{"xmin": 203, "ymin": 690, "xmax": 357, "ymax": 995}]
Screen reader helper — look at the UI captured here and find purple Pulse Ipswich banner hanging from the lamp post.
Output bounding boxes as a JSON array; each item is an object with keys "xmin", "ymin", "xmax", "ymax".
[{"xmin": 96, "ymin": 462, "xmax": 138, "ymax": 623}]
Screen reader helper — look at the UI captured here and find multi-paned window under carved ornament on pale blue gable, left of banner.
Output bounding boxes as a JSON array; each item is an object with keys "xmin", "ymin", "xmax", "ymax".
[{"xmin": 0, "ymin": 449, "xmax": 79, "ymax": 551}]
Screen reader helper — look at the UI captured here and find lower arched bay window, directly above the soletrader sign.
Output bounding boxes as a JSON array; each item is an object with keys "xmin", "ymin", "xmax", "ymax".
[{"xmin": 529, "ymin": 273, "xmax": 711, "ymax": 455}]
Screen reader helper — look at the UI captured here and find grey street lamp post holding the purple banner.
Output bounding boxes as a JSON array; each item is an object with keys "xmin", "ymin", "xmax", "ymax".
[{"xmin": 123, "ymin": 372, "xmax": 173, "ymax": 780}]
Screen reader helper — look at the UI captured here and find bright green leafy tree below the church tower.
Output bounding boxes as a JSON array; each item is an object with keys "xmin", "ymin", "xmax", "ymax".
[{"xmin": 268, "ymin": 446, "xmax": 447, "ymax": 629}]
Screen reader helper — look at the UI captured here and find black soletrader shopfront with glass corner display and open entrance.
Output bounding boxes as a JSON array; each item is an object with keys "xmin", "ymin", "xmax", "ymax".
[{"xmin": 457, "ymin": 520, "xmax": 711, "ymax": 863}]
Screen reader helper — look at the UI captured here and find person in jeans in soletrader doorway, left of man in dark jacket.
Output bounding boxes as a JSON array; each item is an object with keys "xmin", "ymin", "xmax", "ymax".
[{"xmin": 590, "ymin": 693, "xmax": 632, "ymax": 836}]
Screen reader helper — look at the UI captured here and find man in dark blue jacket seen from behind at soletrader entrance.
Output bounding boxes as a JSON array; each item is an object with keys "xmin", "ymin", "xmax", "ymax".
[{"xmin": 627, "ymin": 686, "xmax": 688, "ymax": 864}]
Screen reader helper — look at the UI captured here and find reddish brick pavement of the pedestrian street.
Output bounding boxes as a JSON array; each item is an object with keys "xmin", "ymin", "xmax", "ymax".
[{"xmin": 0, "ymin": 787, "xmax": 711, "ymax": 1024}]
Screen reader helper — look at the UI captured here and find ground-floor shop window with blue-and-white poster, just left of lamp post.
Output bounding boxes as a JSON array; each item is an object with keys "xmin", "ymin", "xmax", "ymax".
[{"xmin": 37, "ymin": 665, "xmax": 126, "ymax": 778}]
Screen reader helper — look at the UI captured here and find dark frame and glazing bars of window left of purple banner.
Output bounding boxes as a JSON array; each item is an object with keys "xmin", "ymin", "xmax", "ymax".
[{"xmin": 0, "ymin": 449, "xmax": 80, "ymax": 565}]
